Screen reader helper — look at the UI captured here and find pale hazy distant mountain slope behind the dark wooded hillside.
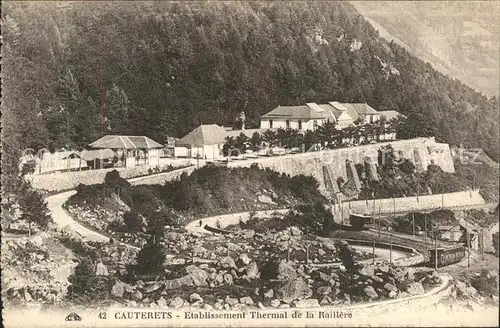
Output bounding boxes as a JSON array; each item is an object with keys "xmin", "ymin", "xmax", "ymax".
[{"xmin": 352, "ymin": 1, "xmax": 500, "ymax": 97}]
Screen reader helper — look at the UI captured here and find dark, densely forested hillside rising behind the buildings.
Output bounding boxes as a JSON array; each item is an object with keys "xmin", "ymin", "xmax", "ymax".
[{"xmin": 2, "ymin": 1, "xmax": 499, "ymax": 165}]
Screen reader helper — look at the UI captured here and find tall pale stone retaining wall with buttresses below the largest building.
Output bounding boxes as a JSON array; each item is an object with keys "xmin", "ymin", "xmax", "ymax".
[{"xmin": 228, "ymin": 138, "xmax": 455, "ymax": 194}]
